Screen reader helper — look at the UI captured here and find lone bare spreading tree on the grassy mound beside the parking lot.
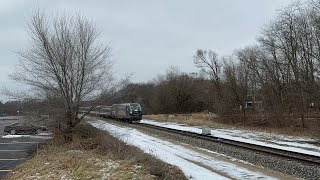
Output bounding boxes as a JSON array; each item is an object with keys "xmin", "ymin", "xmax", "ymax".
[{"xmin": 12, "ymin": 11, "xmax": 113, "ymax": 140}]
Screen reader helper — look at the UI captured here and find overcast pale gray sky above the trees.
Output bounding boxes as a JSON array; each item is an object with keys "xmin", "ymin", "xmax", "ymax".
[{"xmin": 0, "ymin": 0, "xmax": 292, "ymax": 100}]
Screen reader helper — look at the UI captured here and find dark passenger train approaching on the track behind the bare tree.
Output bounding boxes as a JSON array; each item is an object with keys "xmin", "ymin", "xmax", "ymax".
[{"xmin": 79, "ymin": 103, "xmax": 142, "ymax": 123}]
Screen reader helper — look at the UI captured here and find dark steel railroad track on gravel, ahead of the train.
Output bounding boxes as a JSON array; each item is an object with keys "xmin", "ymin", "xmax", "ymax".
[{"xmin": 136, "ymin": 123, "xmax": 320, "ymax": 166}]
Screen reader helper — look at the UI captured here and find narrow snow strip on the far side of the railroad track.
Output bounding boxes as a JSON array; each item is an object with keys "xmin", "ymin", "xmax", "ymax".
[{"xmin": 140, "ymin": 119, "xmax": 320, "ymax": 157}]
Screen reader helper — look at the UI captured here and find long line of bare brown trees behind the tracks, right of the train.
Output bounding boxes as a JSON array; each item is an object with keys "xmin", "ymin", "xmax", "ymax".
[{"xmin": 118, "ymin": 1, "xmax": 320, "ymax": 131}]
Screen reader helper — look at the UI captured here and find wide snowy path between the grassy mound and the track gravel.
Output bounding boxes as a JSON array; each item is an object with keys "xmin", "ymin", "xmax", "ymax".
[{"xmin": 88, "ymin": 119, "xmax": 290, "ymax": 179}]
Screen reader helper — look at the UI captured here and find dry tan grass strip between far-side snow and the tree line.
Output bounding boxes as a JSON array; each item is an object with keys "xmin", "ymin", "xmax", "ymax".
[{"xmin": 143, "ymin": 113, "xmax": 320, "ymax": 138}]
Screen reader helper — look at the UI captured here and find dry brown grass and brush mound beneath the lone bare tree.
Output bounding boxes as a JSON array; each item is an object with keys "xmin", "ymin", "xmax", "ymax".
[{"xmin": 7, "ymin": 121, "xmax": 186, "ymax": 180}]
